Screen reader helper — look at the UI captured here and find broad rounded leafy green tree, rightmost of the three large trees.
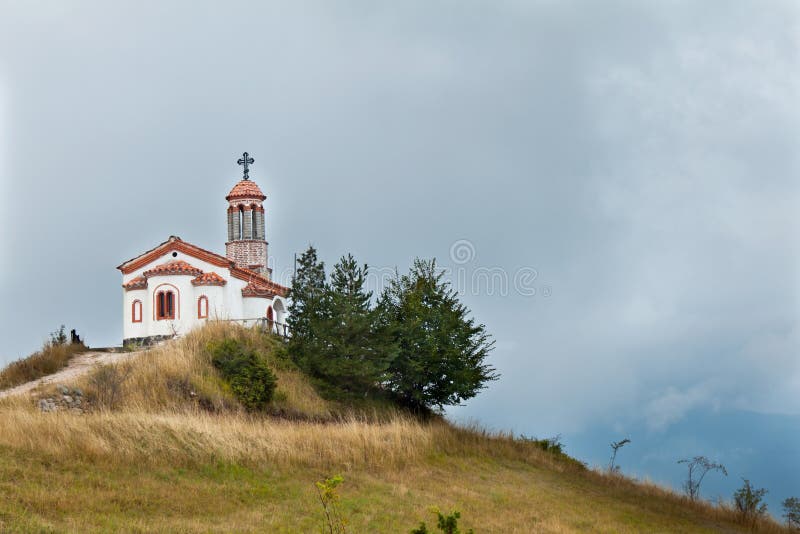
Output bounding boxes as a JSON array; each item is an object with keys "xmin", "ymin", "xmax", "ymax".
[{"xmin": 380, "ymin": 259, "xmax": 498, "ymax": 409}]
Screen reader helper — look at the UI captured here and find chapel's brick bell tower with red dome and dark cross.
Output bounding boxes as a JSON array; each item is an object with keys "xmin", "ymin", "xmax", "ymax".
[{"xmin": 225, "ymin": 152, "xmax": 271, "ymax": 278}]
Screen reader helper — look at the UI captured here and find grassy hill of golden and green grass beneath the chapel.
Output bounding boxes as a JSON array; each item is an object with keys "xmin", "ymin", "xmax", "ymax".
[{"xmin": 0, "ymin": 324, "xmax": 788, "ymax": 532}]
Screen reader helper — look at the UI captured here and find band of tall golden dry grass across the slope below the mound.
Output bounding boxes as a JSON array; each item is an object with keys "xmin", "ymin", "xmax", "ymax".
[{"xmin": 0, "ymin": 406, "xmax": 577, "ymax": 471}]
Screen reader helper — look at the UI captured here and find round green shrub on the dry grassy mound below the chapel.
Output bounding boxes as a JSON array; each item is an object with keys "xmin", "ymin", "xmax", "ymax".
[{"xmin": 208, "ymin": 339, "xmax": 277, "ymax": 411}]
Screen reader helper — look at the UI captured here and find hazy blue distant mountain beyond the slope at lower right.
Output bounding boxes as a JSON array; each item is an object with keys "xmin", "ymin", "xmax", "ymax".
[{"xmin": 564, "ymin": 411, "xmax": 800, "ymax": 517}]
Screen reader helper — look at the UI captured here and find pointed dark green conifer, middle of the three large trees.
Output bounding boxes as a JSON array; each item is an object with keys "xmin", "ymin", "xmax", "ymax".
[{"xmin": 317, "ymin": 254, "xmax": 397, "ymax": 394}]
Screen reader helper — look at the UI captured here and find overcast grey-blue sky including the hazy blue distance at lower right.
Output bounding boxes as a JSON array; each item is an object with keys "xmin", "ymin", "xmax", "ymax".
[{"xmin": 0, "ymin": 0, "xmax": 800, "ymax": 516}]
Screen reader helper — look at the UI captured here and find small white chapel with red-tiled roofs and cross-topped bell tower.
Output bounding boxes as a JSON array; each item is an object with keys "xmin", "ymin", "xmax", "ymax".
[{"xmin": 117, "ymin": 152, "xmax": 288, "ymax": 346}]
